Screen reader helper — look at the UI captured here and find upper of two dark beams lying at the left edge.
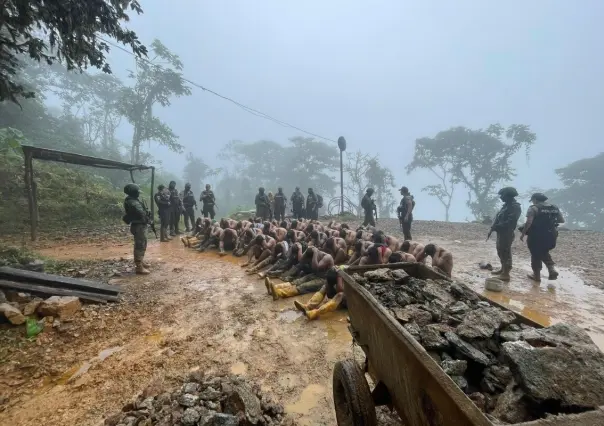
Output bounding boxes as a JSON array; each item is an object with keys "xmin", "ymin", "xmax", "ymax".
[{"xmin": 0, "ymin": 266, "xmax": 121, "ymax": 296}]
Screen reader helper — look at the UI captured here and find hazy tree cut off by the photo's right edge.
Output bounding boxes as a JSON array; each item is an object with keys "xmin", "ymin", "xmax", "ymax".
[{"xmin": 545, "ymin": 153, "xmax": 604, "ymax": 231}]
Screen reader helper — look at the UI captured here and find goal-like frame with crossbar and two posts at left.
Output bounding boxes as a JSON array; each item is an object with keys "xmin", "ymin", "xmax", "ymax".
[{"xmin": 21, "ymin": 145, "xmax": 155, "ymax": 241}]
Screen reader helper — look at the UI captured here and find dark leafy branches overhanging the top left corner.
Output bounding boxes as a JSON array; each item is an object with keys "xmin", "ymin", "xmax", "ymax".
[{"xmin": 0, "ymin": 0, "xmax": 147, "ymax": 103}]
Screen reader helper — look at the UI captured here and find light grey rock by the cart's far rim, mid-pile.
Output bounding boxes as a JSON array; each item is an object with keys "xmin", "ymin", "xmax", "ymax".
[{"xmin": 457, "ymin": 306, "xmax": 516, "ymax": 339}]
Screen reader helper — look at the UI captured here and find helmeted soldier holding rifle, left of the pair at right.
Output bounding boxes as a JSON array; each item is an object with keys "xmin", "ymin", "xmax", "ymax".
[{"xmin": 491, "ymin": 186, "xmax": 522, "ymax": 281}]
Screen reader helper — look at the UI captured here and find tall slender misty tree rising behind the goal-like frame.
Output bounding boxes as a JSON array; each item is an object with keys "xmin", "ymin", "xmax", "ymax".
[{"xmin": 122, "ymin": 39, "xmax": 191, "ymax": 164}]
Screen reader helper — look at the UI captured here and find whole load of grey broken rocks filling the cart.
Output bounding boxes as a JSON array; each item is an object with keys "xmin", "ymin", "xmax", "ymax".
[{"xmin": 353, "ymin": 269, "xmax": 604, "ymax": 423}]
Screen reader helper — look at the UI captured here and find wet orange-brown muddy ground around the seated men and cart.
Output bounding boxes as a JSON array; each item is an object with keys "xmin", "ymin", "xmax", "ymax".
[{"xmin": 0, "ymin": 220, "xmax": 604, "ymax": 426}]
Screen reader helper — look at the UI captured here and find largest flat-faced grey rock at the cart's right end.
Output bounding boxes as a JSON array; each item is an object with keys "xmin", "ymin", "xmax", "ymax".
[{"xmin": 502, "ymin": 341, "xmax": 604, "ymax": 410}]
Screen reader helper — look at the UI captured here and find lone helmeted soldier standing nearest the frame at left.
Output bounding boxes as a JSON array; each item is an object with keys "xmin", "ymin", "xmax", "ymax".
[{"xmin": 123, "ymin": 183, "xmax": 151, "ymax": 275}]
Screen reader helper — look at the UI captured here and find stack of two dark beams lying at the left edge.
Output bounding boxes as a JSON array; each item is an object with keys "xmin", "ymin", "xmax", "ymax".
[{"xmin": 0, "ymin": 266, "xmax": 121, "ymax": 303}]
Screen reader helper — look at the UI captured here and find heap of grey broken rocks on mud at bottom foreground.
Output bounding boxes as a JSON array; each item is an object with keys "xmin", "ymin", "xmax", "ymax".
[{"xmin": 105, "ymin": 371, "xmax": 292, "ymax": 426}]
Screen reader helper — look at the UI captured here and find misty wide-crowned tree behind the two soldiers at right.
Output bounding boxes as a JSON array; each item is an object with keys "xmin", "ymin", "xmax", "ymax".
[{"xmin": 407, "ymin": 124, "xmax": 537, "ymax": 219}]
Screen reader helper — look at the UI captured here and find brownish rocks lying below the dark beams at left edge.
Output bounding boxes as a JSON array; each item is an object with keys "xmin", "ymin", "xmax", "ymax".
[{"xmin": 0, "ymin": 291, "xmax": 82, "ymax": 325}]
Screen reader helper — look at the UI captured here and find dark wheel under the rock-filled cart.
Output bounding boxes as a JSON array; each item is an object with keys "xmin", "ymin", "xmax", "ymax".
[{"xmin": 333, "ymin": 359, "xmax": 377, "ymax": 426}]
